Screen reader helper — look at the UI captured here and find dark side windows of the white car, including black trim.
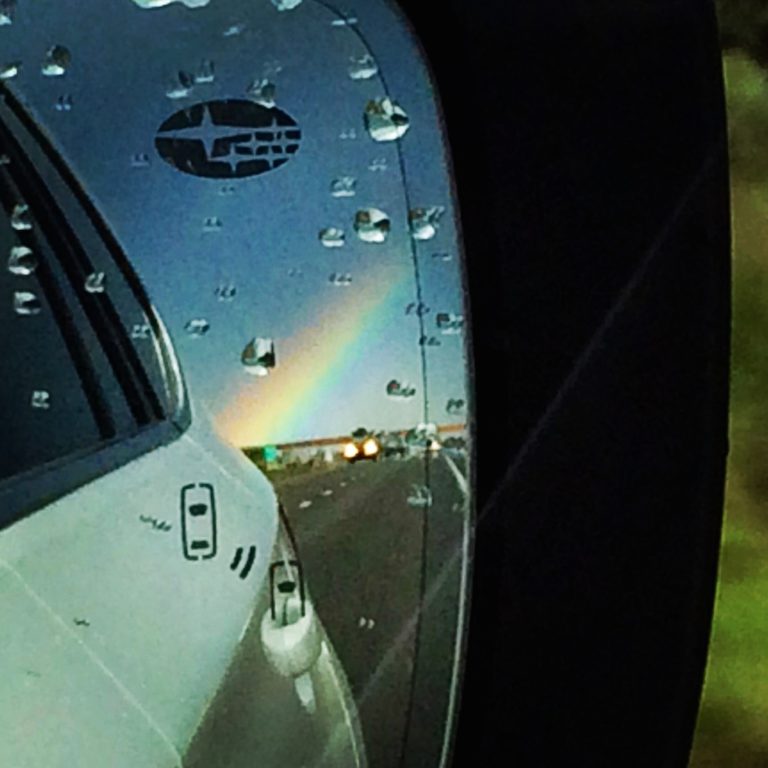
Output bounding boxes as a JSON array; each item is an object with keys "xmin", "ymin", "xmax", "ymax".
[{"xmin": 0, "ymin": 88, "xmax": 188, "ymax": 524}]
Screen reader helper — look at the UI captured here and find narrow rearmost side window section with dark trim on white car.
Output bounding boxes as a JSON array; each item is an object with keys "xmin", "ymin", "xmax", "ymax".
[{"xmin": 0, "ymin": 88, "xmax": 184, "ymax": 426}]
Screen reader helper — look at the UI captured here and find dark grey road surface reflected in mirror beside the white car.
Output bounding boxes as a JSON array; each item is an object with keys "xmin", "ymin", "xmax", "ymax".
[{"xmin": 271, "ymin": 454, "xmax": 467, "ymax": 768}]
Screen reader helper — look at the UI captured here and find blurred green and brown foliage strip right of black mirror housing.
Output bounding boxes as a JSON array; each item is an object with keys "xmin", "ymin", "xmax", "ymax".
[{"xmin": 690, "ymin": 10, "xmax": 768, "ymax": 768}]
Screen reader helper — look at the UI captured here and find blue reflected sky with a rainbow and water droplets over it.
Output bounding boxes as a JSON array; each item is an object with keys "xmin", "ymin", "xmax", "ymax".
[{"xmin": 4, "ymin": 0, "xmax": 466, "ymax": 446}]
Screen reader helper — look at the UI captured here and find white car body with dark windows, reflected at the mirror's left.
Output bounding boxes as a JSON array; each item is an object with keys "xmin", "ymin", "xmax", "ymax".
[{"xmin": 0, "ymin": 73, "xmax": 367, "ymax": 768}]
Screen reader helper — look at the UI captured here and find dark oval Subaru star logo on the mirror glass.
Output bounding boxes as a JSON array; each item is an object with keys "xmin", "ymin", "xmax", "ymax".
[{"xmin": 155, "ymin": 99, "xmax": 301, "ymax": 179}]
